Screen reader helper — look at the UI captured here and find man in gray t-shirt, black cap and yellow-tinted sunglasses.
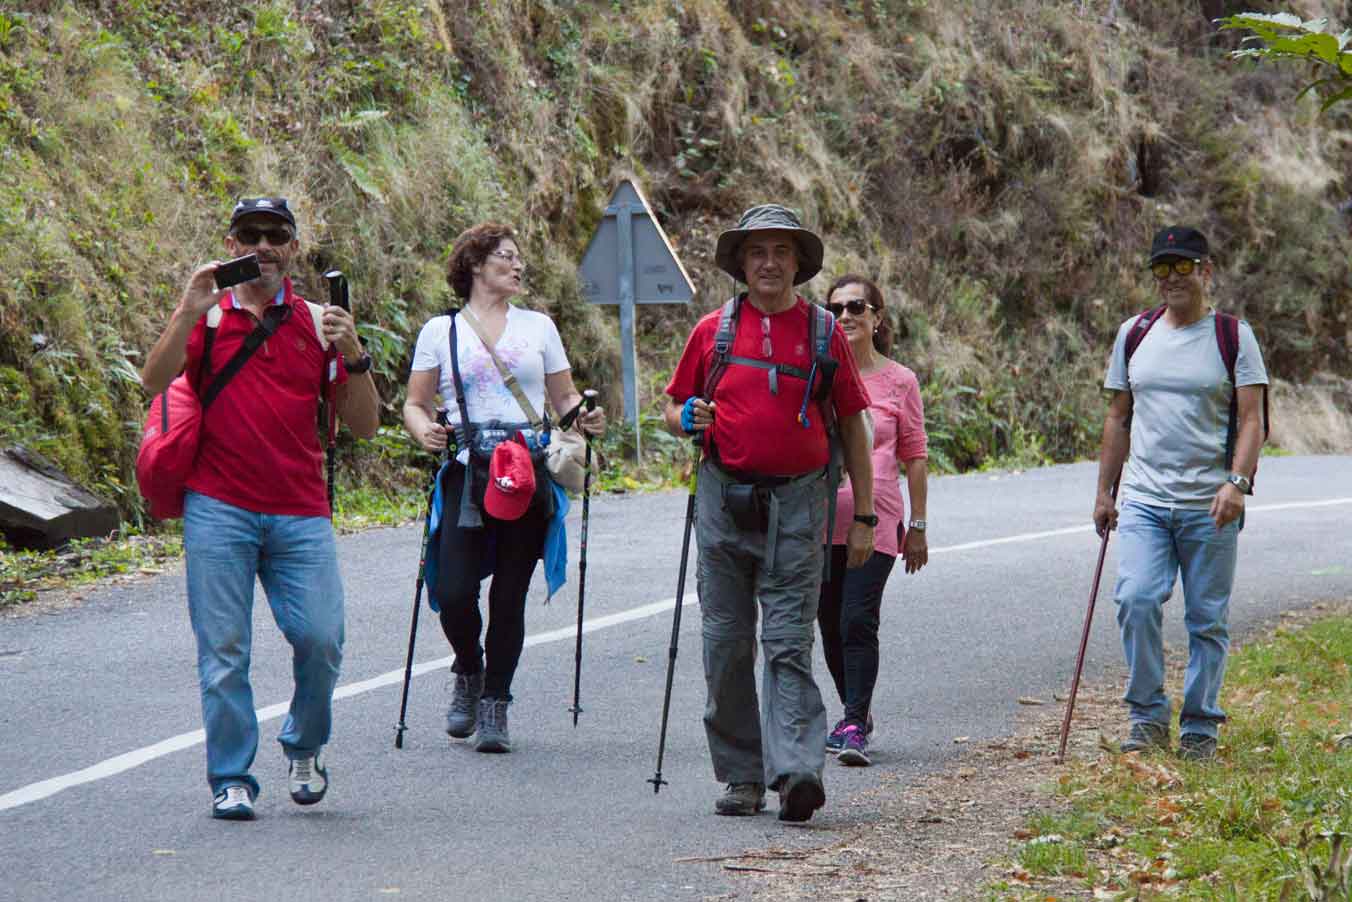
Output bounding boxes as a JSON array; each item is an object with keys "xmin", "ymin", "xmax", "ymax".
[{"xmin": 1094, "ymin": 226, "xmax": 1268, "ymax": 759}]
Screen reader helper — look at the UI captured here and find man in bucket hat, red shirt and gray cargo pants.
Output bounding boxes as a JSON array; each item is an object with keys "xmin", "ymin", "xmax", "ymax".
[{"xmin": 665, "ymin": 204, "xmax": 877, "ymax": 821}]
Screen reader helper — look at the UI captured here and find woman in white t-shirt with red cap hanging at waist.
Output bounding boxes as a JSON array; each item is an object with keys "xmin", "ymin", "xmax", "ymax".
[{"xmin": 404, "ymin": 222, "xmax": 606, "ymax": 752}]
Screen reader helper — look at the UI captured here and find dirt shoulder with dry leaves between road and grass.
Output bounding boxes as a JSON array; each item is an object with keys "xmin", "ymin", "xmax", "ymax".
[{"xmin": 691, "ymin": 599, "xmax": 1352, "ymax": 902}]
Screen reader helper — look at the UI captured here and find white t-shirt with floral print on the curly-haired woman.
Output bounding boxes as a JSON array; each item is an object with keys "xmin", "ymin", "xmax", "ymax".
[{"xmin": 412, "ymin": 307, "xmax": 571, "ymax": 462}]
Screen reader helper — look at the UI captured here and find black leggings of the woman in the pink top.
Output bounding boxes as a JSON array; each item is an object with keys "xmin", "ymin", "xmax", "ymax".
[{"xmin": 817, "ymin": 545, "xmax": 896, "ymax": 726}]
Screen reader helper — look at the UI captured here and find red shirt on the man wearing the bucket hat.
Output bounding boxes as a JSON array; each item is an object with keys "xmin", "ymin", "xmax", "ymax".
[{"xmin": 667, "ymin": 298, "xmax": 868, "ymax": 476}]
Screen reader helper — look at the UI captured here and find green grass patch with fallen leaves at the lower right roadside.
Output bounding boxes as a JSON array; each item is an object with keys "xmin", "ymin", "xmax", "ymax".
[{"xmin": 990, "ymin": 615, "xmax": 1352, "ymax": 901}]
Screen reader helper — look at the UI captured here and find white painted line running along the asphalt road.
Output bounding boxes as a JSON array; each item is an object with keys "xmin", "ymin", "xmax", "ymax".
[{"xmin": 0, "ymin": 498, "xmax": 1352, "ymax": 811}]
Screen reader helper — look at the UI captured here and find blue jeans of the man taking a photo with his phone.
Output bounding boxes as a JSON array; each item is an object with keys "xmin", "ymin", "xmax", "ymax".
[{"xmin": 183, "ymin": 492, "xmax": 343, "ymax": 797}]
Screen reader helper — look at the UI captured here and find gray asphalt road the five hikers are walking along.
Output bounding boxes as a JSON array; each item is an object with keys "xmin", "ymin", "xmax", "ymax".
[{"xmin": 0, "ymin": 457, "xmax": 1352, "ymax": 902}]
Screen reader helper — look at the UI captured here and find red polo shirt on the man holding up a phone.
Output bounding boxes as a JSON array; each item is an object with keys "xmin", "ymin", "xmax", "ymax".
[{"xmin": 184, "ymin": 279, "xmax": 347, "ymax": 517}]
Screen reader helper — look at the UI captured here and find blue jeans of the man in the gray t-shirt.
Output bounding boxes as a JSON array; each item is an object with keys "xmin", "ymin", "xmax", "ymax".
[{"xmin": 1115, "ymin": 500, "xmax": 1240, "ymax": 737}]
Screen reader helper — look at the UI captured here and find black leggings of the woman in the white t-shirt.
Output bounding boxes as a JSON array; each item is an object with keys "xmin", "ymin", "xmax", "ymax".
[{"xmin": 437, "ymin": 464, "xmax": 549, "ymax": 699}]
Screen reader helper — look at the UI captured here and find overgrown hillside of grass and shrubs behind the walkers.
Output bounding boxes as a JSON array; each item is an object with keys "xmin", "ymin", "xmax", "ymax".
[{"xmin": 0, "ymin": 0, "xmax": 1352, "ymax": 529}]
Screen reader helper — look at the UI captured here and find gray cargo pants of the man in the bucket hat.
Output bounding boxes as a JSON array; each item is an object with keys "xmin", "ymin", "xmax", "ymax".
[{"xmin": 695, "ymin": 461, "xmax": 826, "ymax": 788}]
